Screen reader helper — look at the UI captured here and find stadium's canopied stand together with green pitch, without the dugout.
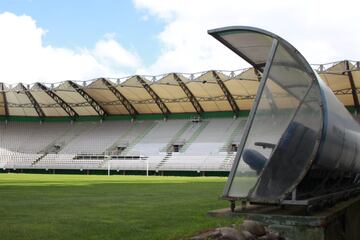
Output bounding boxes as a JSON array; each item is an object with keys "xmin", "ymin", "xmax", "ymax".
[{"xmin": 0, "ymin": 60, "xmax": 360, "ymax": 240}]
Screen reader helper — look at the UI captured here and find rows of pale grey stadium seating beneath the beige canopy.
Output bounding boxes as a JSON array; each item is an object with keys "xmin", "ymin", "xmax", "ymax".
[{"xmin": 1, "ymin": 118, "xmax": 244, "ymax": 171}]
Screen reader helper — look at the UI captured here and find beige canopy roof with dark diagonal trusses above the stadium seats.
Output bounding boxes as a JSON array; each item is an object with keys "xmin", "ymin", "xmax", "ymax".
[{"xmin": 0, "ymin": 60, "xmax": 360, "ymax": 118}]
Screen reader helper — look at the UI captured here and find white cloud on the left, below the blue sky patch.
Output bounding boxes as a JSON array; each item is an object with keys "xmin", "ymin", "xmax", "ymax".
[{"xmin": 0, "ymin": 12, "xmax": 141, "ymax": 83}]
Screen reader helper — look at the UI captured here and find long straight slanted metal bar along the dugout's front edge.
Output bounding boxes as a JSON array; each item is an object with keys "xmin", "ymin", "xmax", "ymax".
[{"xmin": 223, "ymin": 38, "xmax": 278, "ymax": 198}]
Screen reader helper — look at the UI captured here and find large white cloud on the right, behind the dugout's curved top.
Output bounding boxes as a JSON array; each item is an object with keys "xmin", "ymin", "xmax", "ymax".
[{"xmin": 134, "ymin": 0, "xmax": 360, "ymax": 74}]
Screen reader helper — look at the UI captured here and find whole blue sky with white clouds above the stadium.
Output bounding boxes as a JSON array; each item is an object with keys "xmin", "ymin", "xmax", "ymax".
[{"xmin": 0, "ymin": 0, "xmax": 360, "ymax": 84}]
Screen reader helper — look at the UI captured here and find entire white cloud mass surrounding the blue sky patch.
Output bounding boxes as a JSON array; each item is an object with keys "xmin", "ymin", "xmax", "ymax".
[{"xmin": 0, "ymin": 0, "xmax": 360, "ymax": 83}]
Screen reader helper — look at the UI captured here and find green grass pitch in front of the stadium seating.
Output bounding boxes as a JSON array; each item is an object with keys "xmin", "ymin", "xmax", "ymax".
[{"xmin": 0, "ymin": 174, "xmax": 241, "ymax": 240}]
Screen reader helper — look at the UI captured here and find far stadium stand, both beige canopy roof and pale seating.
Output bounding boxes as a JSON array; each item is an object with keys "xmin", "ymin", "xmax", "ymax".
[{"xmin": 0, "ymin": 61, "xmax": 360, "ymax": 172}]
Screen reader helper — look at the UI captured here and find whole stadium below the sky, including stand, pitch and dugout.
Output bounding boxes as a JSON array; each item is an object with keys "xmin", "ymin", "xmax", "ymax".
[{"xmin": 0, "ymin": 26, "xmax": 360, "ymax": 240}]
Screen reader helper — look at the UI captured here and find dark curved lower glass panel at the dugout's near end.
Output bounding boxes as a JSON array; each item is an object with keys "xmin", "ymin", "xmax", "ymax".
[{"xmin": 251, "ymin": 84, "xmax": 321, "ymax": 201}]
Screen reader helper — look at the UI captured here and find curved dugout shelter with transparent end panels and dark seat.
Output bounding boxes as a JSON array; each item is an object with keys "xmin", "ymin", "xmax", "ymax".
[{"xmin": 209, "ymin": 26, "xmax": 360, "ymax": 205}]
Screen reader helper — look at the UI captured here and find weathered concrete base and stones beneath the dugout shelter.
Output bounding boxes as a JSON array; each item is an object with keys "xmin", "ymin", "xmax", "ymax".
[{"xmin": 209, "ymin": 196, "xmax": 360, "ymax": 240}]
